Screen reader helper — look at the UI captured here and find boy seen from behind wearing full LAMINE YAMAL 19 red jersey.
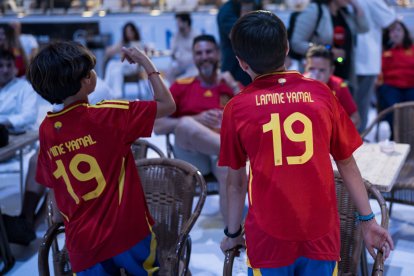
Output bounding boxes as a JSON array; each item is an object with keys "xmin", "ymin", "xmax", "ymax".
[{"xmin": 219, "ymin": 11, "xmax": 394, "ymax": 276}]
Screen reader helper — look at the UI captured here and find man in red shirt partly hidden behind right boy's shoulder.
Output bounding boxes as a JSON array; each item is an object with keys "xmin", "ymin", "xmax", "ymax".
[{"xmin": 304, "ymin": 45, "xmax": 361, "ymax": 128}]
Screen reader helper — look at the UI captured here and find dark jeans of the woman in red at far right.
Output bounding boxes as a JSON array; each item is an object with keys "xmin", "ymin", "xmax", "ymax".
[{"xmin": 377, "ymin": 84, "xmax": 414, "ymax": 140}]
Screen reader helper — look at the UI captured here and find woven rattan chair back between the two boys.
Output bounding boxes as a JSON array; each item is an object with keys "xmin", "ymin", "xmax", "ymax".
[{"xmin": 136, "ymin": 158, "xmax": 207, "ymax": 275}]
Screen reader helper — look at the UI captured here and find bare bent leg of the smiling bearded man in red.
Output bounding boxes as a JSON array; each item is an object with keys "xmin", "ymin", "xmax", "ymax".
[{"xmin": 174, "ymin": 117, "xmax": 220, "ymax": 155}]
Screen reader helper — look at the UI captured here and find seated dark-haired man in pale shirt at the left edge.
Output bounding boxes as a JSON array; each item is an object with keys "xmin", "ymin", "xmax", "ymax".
[{"xmin": 0, "ymin": 50, "xmax": 38, "ymax": 133}]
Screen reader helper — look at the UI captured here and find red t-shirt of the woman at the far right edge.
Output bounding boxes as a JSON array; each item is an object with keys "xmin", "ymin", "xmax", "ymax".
[{"xmin": 382, "ymin": 45, "xmax": 414, "ymax": 89}]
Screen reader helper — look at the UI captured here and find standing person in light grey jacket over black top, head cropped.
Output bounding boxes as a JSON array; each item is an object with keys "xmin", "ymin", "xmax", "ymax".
[{"xmin": 290, "ymin": 0, "xmax": 369, "ymax": 92}]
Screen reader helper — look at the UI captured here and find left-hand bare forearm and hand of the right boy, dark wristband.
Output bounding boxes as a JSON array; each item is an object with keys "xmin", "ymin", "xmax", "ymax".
[{"xmin": 220, "ymin": 167, "xmax": 247, "ymax": 251}]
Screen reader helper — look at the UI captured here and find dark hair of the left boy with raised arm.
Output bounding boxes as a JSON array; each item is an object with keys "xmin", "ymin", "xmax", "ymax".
[{"xmin": 26, "ymin": 41, "xmax": 96, "ymax": 104}]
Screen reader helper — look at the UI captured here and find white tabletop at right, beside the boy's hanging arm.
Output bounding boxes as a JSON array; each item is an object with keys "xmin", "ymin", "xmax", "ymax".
[{"xmin": 332, "ymin": 143, "xmax": 410, "ymax": 192}]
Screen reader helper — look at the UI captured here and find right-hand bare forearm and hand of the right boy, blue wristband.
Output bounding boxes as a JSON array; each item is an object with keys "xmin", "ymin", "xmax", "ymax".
[{"xmin": 336, "ymin": 156, "xmax": 394, "ymax": 258}]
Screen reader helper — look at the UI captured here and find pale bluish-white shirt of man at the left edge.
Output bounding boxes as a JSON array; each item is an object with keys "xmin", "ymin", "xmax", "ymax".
[{"xmin": 0, "ymin": 78, "xmax": 38, "ymax": 130}]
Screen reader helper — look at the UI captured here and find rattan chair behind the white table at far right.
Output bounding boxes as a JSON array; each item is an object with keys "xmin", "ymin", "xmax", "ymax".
[{"xmin": 361, "ymin": 102, "xmax": 414, "ymax": 214}]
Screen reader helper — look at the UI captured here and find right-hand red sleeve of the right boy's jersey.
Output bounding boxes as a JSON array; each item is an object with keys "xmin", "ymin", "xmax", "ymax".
[{"xmin": 330, "ymin": 95, "xmax": 362, "ymax": 160}]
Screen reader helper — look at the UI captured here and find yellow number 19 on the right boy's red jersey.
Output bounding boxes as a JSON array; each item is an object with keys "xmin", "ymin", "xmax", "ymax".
[{"xmin": 263, "ymin": 112, "xmax": 313, "ymax": 166}]
